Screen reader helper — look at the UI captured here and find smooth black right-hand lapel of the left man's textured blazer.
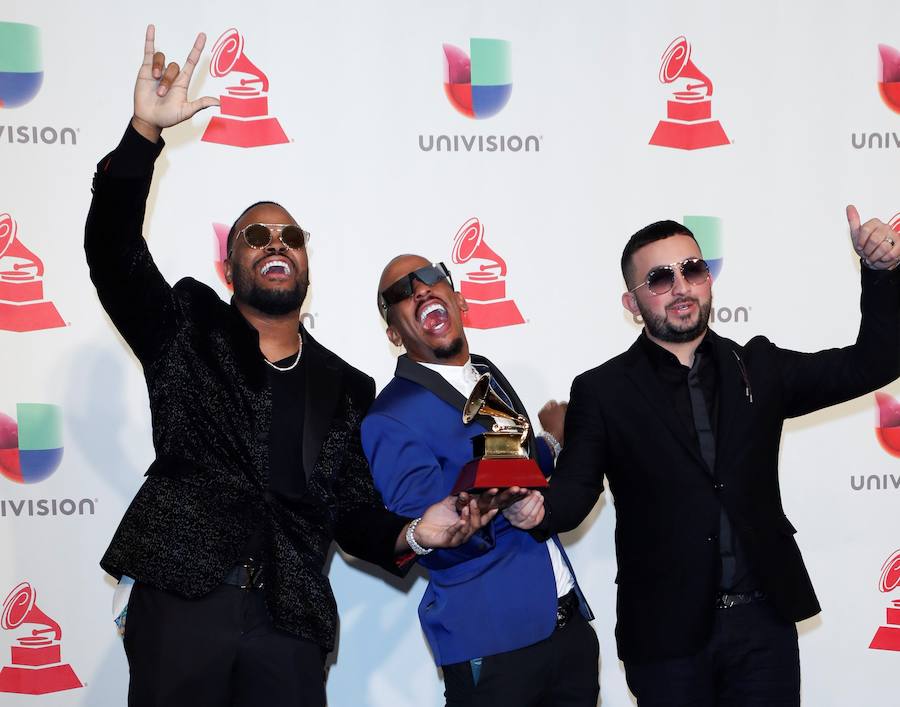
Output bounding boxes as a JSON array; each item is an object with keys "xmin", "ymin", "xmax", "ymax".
[{"xmin": 301, "ymin": 329, "xmax": 341, "ymax": 479}]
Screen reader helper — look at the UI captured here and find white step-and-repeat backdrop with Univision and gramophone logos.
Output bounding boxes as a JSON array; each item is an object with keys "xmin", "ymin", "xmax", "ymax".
[{"xmin": 0, "ymin": 0, "xmax": 900, "ymax": 707}]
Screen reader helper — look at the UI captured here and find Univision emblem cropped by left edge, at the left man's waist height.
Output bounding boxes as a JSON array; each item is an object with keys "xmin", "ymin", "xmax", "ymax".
[{"xmin": 0, "ymin": 403, "xmax": 63, "ymax": 484}]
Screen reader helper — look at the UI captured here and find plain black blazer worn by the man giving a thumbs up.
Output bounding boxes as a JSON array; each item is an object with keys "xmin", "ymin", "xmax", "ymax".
[{"xmin": 545, "ymin": 268, "xmax": 900, "ymax": 662}]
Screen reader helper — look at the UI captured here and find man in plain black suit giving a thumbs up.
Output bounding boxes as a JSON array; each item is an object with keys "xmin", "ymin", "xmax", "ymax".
[{"xmin": 541, "ymin": 213, "xmax": 900, "ymax": 707}]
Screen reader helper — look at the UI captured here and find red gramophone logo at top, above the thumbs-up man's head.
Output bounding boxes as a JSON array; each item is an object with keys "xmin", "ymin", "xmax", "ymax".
[{"xmin": 650, "ymin": 36, "xmax": 729, "ymax": 150}]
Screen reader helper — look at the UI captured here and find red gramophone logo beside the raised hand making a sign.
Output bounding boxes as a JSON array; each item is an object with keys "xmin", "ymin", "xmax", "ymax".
[{"xmin": 201, "ymin": 27, "xmax": 288, "ymax": 147}]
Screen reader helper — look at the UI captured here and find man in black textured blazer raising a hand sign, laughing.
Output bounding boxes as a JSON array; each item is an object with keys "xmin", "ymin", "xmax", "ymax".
[{"xmin": 85, "ymin": 26, "xmax": 496, "ymax": 707}]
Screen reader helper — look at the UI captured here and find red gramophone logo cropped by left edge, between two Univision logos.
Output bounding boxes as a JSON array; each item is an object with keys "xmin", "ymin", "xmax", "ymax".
[{"xmin": 0, "ymin": 214, "xmax": 66, "ymax": 331}]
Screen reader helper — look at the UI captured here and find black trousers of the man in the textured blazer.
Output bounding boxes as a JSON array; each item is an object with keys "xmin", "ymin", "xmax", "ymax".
[{"xmin": 125, "ymin": 583, "xmax": 325, "ymax": 707}]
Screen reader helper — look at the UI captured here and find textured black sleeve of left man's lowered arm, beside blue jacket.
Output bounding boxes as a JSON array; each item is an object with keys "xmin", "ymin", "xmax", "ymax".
[{"xmin": 335, "ymin": 378, "xmax": 413, "ymax": 576}]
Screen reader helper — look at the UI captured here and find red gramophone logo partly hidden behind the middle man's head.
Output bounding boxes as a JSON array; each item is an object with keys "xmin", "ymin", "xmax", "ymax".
[{"xmin": 451, "ymin": 218, "xmax": 525, "ymax": 329}]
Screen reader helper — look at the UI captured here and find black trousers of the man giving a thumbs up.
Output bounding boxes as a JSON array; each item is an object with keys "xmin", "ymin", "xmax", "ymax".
[{"xmin": 625, "ymin": 601, "xmax": 800, "ymax": 707}]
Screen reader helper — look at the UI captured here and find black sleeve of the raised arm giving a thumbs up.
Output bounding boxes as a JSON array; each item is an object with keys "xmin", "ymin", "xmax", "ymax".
[{"xmin": 768, "ymin": 267, "xmax": 900, "ymax": 417}]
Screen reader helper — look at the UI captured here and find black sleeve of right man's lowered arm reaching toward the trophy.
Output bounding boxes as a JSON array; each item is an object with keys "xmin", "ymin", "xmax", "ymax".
[{"xmin": 538, "ymin": 376, "xmax": 607, "ymax": 537}]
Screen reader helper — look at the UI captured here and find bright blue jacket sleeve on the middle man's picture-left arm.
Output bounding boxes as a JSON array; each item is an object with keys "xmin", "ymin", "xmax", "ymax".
[{"xmin": 362, "ymin": 413, "xmax": 494, "ymax": 569}]
